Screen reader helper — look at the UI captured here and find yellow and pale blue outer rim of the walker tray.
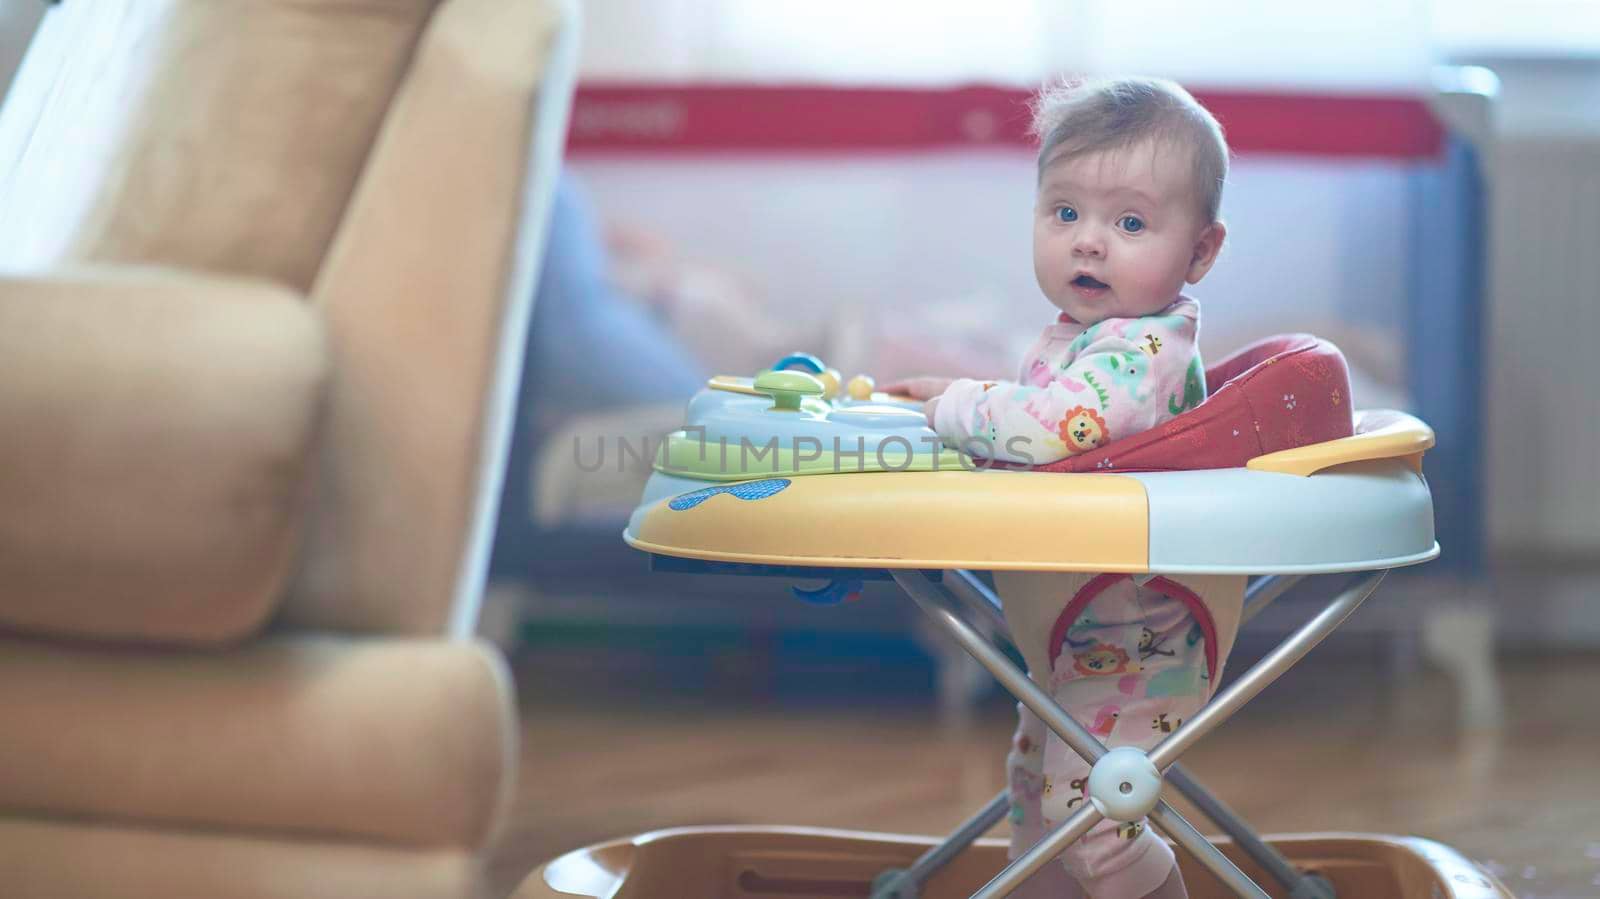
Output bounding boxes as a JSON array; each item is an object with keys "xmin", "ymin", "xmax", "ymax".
[{"xmin": 624, "ymin": 413, "xmax": 1438, "ymax": 574}]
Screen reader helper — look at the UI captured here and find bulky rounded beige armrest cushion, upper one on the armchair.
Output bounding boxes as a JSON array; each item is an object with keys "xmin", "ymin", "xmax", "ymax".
[{"xmin": 0, "ymin": 262, "xmax": 328, "ymax": 643}]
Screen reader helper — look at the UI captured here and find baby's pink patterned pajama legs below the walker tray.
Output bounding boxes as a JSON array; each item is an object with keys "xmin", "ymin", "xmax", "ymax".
[{"xmin": 995, "ymin": 573, "xmax": 1245, "ymax": 899}]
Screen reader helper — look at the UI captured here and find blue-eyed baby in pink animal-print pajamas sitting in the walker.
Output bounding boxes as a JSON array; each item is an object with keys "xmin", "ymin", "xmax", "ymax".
[{"xmin": 885, "ymin": 78, "xmax": 1245, "ymax": 897}]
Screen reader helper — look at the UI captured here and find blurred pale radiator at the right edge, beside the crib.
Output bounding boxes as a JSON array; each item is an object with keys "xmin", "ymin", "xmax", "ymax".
[{"xmin": 1485, "ymin": 138, "xmax": 1600, "ymax": 563}]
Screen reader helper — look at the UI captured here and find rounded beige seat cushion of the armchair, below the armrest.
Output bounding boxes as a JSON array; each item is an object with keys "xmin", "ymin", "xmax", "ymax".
[{"xmin": 0, "ymin": 635, "xmax": 517, "ymax": 844}]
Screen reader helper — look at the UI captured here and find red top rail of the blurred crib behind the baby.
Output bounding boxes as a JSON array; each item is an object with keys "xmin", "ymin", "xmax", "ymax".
[{"xmin": 568, "ymin": 83, "xmax": 1443, "ymax": 158}]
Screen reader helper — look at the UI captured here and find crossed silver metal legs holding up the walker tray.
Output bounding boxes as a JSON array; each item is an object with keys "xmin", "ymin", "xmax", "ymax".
[{"xmin": 872, "ymin": 569, "xmax": 1389, "ymax": 899}]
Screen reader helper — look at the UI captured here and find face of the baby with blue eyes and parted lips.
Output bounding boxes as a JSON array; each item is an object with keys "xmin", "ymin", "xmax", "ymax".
[{"xmin": 1034, "ymin": 141, "xmax": 1226, "ymax": 325}]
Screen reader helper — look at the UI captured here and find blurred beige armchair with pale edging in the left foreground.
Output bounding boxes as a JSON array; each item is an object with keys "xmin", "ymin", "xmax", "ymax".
[{"xmin": 0, "ymin": 0, "xmax": 574, "ymax": 899}]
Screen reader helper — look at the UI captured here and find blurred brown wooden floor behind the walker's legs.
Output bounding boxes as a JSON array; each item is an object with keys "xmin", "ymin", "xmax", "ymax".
[{"xmin": 494, "ymin": 643, "xmax": 1600, "ymax": 899}]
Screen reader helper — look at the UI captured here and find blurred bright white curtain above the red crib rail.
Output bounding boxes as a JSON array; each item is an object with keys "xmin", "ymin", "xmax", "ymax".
[{"xmin": 584, "ymin": 0, "xmax": 1440, "ymax": 90}]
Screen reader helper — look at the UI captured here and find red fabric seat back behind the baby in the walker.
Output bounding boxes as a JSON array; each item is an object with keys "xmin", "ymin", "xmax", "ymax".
[{"xmin": 1034, "ymin": 334, "xmax": 1355, "ymax": 472}]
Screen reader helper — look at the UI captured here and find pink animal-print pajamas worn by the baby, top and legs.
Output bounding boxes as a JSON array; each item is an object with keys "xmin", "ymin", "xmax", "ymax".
[{"xmin": 933, "ymin": 296, "xmax": 1245, "ymax": 899}]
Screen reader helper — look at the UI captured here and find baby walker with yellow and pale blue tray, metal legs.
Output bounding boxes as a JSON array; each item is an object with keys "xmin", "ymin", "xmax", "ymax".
[{"xmin": 517, "ymin": 334, "xmax": 1512, "ymax": 899}]
